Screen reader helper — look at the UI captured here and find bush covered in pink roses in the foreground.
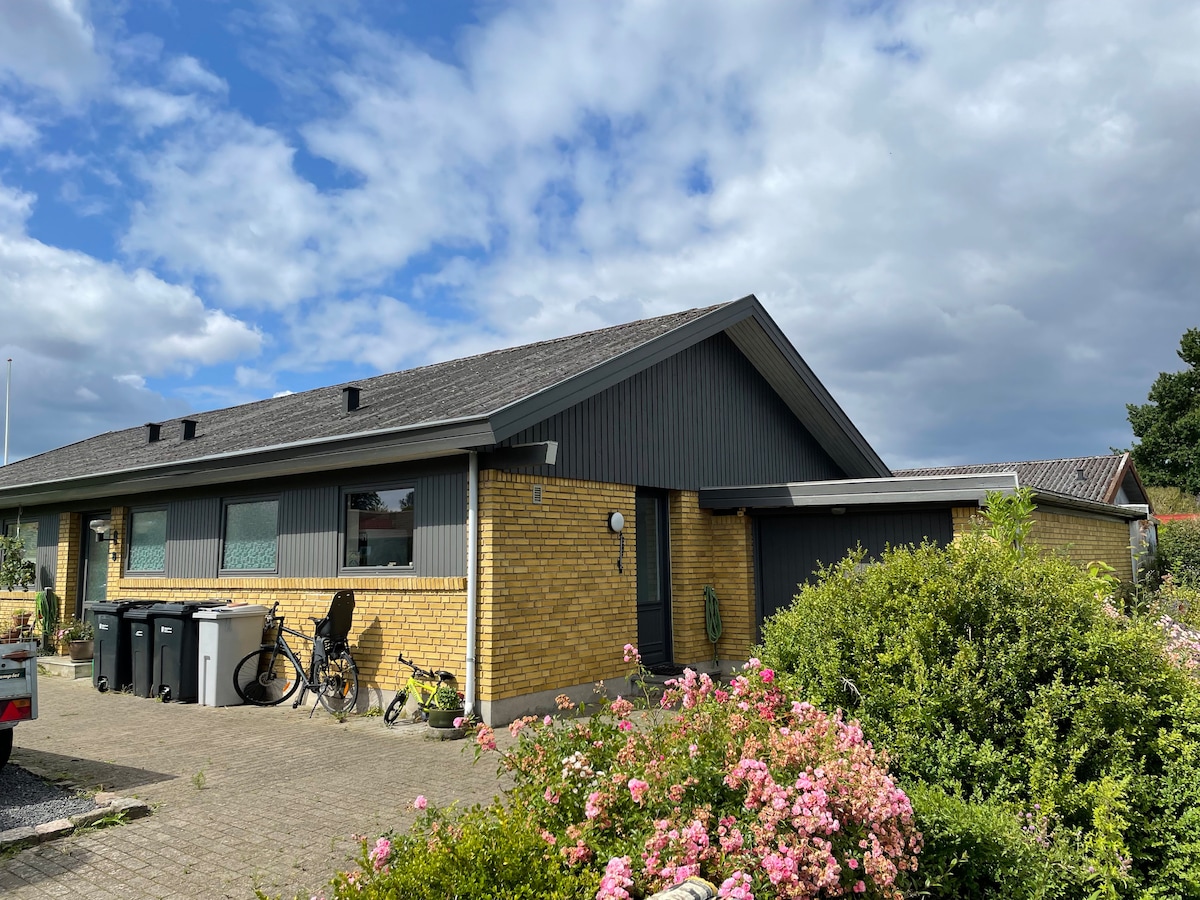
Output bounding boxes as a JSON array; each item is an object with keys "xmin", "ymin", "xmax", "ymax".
[{"xmin": 479, "ymin": 646, "xmax": 920, "ymax": 900}]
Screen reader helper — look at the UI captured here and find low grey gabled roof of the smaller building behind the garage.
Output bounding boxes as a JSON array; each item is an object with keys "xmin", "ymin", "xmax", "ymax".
[{"xmin": 894, "ymin": 454, "xmax": 1150, "ymax": 504}]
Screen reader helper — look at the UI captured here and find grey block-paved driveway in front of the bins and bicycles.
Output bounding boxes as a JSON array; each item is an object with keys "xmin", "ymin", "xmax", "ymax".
[{"xmin": 0, "ymin": 677, "xmax": 511, "ymax": 900}]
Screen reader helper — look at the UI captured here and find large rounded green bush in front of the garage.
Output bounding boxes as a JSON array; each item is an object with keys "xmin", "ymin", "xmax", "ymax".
[{"xmin": 762, "ymin": 534, "xmax": 1200, "ymax": 898}]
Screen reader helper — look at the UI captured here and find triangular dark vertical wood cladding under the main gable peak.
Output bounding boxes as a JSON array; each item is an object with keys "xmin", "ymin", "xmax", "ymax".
[{"xmin": 504, "ymin": 334, "xmax": 845, "ymax": 491}]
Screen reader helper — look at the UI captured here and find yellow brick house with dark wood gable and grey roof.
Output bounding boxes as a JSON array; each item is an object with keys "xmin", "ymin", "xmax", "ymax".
[{"xmin": 0, "ymin": 295, "xmax": 1147, "ymax": 724}]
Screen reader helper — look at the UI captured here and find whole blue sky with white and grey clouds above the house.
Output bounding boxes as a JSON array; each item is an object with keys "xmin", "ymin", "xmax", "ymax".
[{"xmin": 0, "ymin": 0, "xmax": 1200, "ymax": 467}]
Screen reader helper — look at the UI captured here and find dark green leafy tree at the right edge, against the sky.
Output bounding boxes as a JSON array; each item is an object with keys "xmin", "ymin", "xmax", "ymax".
[{"xmin": 1127, "ymin": 328, "xmax": 1200, "ymax": 497}]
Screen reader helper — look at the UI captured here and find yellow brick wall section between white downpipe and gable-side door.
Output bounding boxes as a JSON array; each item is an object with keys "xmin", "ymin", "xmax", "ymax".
[{"xmin": 478, "ymin": 469, "xmax": 637, "ymax": 702}]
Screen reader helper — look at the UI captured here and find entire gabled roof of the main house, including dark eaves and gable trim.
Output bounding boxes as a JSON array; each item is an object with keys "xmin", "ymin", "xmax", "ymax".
[{"xmin": 0, "ymin": 295, "xmax": 888, "ymax": 506}]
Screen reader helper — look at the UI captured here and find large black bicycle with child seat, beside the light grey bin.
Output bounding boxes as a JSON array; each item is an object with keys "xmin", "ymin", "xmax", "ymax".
[{"xmin": 233, "ymin": 590, "xmax": 359, "ymax": 718}]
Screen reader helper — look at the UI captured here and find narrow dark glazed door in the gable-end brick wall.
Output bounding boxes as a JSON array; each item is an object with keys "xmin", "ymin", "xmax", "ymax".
[{"xmin": 636, "ymin": 488, "xmax": 671, "ymax": 666}]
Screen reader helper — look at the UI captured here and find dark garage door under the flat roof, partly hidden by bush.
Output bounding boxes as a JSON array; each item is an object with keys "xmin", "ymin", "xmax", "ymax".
[{"xmin": 755, "ymin": 509, "xmax": 954, "ymax": 624}]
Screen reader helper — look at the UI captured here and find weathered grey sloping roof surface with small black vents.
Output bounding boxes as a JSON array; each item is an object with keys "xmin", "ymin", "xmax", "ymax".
[{"xmin": 0, "ymin": 304, "xmax": 727, "ymax": 487}]
